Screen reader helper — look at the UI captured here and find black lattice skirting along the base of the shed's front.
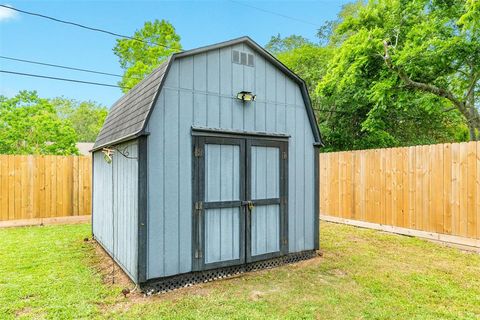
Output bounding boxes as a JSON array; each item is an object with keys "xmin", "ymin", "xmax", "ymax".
[{"xmin": 140, "ymin": 251, "xmax": 316, "ymax": 295}]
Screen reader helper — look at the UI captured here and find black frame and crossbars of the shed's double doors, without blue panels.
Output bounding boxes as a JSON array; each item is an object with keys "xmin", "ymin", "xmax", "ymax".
[{"xmin": 192, "ymin": 127, "xmax": 290, "ymax": 271}]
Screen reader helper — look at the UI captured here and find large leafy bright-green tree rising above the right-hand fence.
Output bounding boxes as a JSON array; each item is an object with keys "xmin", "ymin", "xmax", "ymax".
[{"xmin": 316, "ymin": 0, "xmax": 472, "ymax": 150}]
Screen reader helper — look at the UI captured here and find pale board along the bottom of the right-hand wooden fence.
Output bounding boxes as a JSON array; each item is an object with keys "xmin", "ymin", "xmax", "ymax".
[{"xmin": 320, "ymin": 214, "xmax": 480, "ymax": 253}]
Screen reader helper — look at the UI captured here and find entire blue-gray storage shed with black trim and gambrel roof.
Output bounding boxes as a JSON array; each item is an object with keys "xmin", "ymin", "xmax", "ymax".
[{"xmin": 92, "ymin": 37, "xmax": 321, "ymax": 291}]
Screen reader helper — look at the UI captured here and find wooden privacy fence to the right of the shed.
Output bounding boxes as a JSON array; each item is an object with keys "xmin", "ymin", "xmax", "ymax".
[{"xmin": 320, "ymin": 142, "xmax": 480, "ymax": 239}]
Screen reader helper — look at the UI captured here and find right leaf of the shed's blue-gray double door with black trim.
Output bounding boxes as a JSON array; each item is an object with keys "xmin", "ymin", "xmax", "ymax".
[{"xmin": 246, "ymin": 139, "xmax": 287, "ymax": 262}]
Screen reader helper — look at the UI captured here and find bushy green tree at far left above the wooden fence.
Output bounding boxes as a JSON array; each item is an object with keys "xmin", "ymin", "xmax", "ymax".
[{"xmin": 0, "ymin": 91, "xmax": 78, "ymax": 155}]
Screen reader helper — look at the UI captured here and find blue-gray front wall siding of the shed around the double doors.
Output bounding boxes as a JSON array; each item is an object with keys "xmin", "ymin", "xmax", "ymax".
[{"xmin": 147, "ymin": 44, "xmax": 315, "ymax": 278}]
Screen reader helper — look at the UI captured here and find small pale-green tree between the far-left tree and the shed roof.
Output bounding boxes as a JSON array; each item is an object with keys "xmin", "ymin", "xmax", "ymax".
[{"xmin": 51, "ymin": 98, "xmax": 108, "ymax": 142}]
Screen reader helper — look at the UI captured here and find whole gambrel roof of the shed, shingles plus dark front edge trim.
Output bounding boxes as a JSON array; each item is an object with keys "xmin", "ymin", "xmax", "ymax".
[{"xmin": 93, "ymin": 37, "xmax": 322, "ymax": 151}]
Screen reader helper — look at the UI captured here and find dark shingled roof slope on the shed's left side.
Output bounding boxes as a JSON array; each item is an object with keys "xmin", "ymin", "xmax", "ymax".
[{"xmin": 93, "ymin": 60, "xmax": 168, "ymax": 150}]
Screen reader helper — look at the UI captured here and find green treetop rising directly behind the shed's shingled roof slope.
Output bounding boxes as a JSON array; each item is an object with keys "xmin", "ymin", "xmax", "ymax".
[{"xmin": 113, "ymin": 20, "xmax": 182, "ymax": 92}]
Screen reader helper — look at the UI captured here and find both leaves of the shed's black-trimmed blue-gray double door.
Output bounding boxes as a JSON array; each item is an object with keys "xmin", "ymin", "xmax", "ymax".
[{"xmin": 192, "ymin": 136, "xmax": 288, "ymax": 270}]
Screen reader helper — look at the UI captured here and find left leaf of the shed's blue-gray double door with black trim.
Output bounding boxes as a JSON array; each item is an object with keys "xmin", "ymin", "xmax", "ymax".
[{"xmin": 194, "ymin": 137, "xmax": 245, "ymax": 270}]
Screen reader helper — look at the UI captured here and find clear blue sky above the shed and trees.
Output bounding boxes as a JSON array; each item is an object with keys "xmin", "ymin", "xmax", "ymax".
[{"xmin": 0, "ymin": 0, "xmax": 350, "ymax": 107}]
